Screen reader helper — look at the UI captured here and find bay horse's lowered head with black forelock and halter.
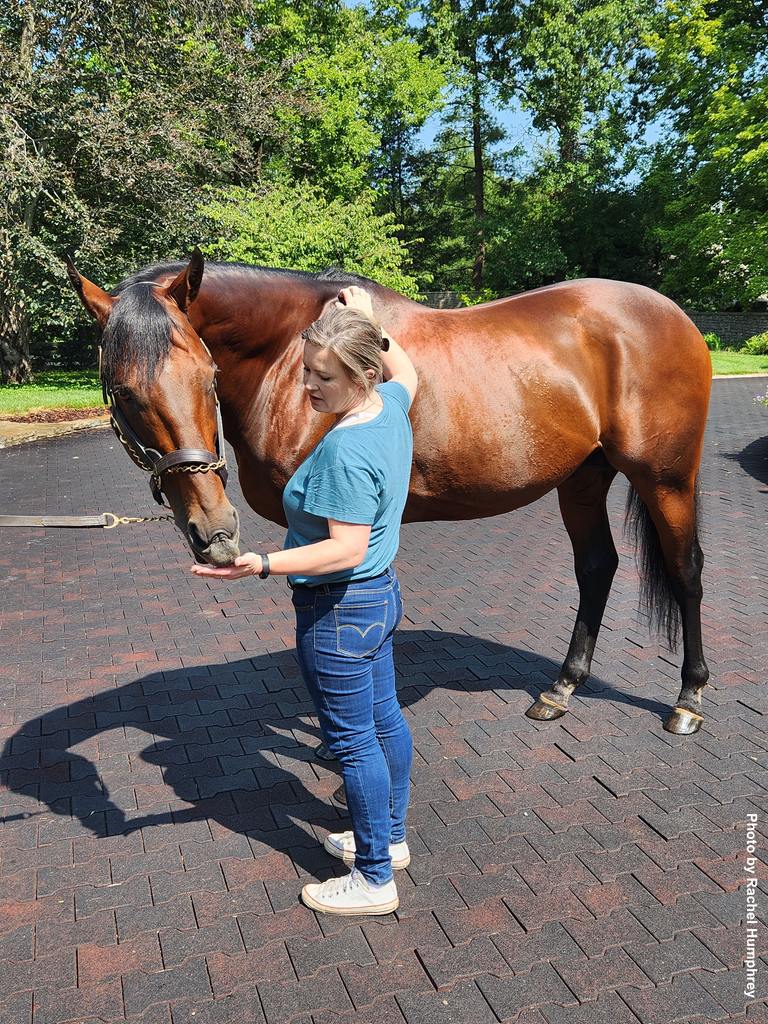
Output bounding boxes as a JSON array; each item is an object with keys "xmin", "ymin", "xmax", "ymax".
[{"xmin": 67, "ymin": 249, "xmax": 240, "ymax": 565}]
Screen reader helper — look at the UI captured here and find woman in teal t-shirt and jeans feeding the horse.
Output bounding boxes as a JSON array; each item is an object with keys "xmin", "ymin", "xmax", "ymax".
[{"xmin": 193, "ymin": 287, "xmax": 417, "ymax": 914}]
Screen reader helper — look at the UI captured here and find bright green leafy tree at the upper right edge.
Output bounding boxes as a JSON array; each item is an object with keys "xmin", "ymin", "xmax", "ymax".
[{"xmin": 647, "ymin": 0, "xmax": 768, "ymax": 309}]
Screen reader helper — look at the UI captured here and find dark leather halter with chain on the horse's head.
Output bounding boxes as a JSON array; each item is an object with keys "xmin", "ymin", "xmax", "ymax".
[{"xmin": 98, "ymin": 339, "xmax": 228, "ymax": 508}]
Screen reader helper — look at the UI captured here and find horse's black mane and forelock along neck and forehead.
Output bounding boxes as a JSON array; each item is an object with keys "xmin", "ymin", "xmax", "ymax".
[{"xmin": 101, "ymin": 262, "xmax": 381, "ymax": 387}]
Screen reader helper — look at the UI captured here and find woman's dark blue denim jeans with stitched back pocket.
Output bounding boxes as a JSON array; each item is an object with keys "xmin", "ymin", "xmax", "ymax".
[{"xmin": 293, "ymin": 566, "xmax": 413, "ymax": 885}]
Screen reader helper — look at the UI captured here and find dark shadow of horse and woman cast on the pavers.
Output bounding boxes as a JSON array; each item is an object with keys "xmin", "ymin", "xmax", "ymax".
[{"xmin": 0, "ymin": 630, "xmax": 668, "ymax": 876}]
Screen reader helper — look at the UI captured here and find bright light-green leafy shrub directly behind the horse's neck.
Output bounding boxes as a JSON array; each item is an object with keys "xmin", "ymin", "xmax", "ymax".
[{"xmin": 200, "ymin": 182, "xmax": 418, "ymax": 297}]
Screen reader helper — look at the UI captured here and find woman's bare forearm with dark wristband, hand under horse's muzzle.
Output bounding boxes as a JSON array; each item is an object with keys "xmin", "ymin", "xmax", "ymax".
[{"xmin": 191, "ymin": 519, "xmax": 371, "ymax": 580}]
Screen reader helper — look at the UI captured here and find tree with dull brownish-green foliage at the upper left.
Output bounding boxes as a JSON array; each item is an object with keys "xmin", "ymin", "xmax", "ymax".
[{"xmin": 0, "ymin": 0, "xmax": 297, "ymax": 380}]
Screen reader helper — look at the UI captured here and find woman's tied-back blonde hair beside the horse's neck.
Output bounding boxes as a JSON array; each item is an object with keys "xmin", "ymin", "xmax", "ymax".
[{"xmin": 301, "ymin": 306, "xmax": 383, "ymax": 395}]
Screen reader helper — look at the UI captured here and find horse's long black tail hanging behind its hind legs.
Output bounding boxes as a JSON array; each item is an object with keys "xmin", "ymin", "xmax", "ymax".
[{"xmin": 625, "ymin": 479, "xmax": 699, "ymax": 650}]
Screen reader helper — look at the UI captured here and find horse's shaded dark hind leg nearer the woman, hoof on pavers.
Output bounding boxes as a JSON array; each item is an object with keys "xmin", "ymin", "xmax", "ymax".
[{"xmin": 525, "ymin": 450, "xmax": 618, "ymax": 722}]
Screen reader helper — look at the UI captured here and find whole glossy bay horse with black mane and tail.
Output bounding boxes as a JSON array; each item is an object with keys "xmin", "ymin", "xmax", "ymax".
[{"xmin": 68, "ymin": 250, "xmax": 712, "ymax": 734}]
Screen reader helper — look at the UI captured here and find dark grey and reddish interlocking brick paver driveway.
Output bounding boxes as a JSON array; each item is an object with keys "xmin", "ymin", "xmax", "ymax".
[{"xmin": 0, "ymin": 380, "xmax": 768, "ymax": 1024}]
